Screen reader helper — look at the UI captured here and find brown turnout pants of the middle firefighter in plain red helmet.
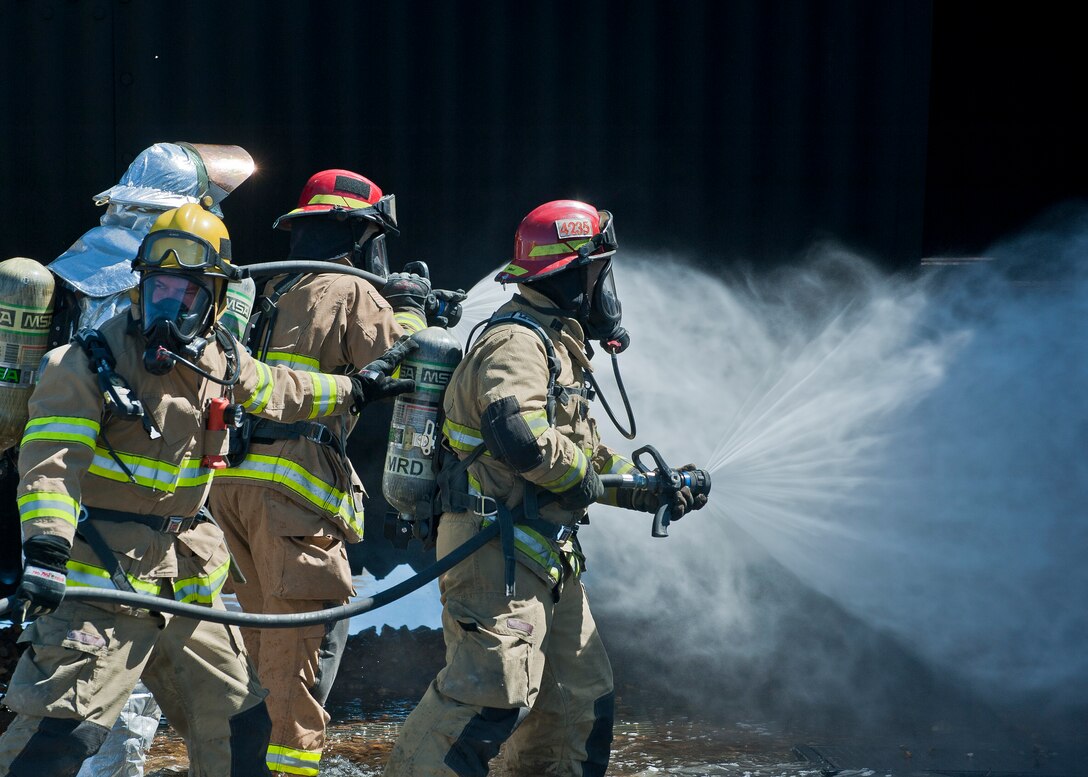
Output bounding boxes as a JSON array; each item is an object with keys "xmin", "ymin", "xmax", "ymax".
[{"xmin": 209, "ymin": 483, "xmax": 354, "ymax": 776}]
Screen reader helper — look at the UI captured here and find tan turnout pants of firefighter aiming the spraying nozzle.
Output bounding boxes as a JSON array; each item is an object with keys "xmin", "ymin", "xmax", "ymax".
[{"xmin": 384, "ymin": 513, "xmax": 614, "ymax": 777}]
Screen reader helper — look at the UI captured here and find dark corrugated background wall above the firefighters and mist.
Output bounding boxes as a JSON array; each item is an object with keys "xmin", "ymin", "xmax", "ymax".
[{"xmin": 0, "ymin": 0, "xmax": 1088, "ymax": 574}]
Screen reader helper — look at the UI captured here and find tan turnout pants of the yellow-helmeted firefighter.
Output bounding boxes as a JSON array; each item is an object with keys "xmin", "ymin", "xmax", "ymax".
[{"xmin": 0, "ymin": 599, "xmax": 270, "ymax": 777}]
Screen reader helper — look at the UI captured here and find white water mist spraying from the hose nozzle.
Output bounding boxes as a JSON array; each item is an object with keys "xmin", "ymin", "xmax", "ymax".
[{"xmin": 582, "ymin": 210, "xmax": 1088, "ymax": 703}]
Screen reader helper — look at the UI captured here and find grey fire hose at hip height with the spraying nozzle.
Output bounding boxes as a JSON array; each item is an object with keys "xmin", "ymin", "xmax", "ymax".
[{"xmin": 0, "ymin": 454, "xmax": 710, "ymax": 629}]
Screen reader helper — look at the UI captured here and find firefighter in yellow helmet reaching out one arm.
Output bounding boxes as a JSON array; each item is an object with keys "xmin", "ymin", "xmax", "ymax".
[{"xmin": 0, "ymin": 204, "xmax": 411, "ymax": 777}]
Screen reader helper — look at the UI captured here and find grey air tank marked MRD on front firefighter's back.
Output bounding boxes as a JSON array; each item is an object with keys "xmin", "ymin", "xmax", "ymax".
[{"xmin": 382, "ymin": 326, "xmax": 463, "ymax": 520}]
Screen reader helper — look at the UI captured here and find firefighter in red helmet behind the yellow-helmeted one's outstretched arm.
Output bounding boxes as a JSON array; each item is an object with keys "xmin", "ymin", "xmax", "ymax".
[{"xmin": 210, "ymin": 170, "xmax": 461, "ymax": 775}]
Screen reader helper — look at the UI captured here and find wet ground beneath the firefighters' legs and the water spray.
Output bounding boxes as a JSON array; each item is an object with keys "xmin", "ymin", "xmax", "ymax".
[{"xmin": 145, "ymin": 700, "xmax": 1088, "ymax": 777}]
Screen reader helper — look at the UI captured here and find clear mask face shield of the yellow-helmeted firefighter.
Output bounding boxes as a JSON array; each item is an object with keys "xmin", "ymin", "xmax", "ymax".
[{"xmin": 139, "ymin": 271, "xmax": 215, "ymax": 350}]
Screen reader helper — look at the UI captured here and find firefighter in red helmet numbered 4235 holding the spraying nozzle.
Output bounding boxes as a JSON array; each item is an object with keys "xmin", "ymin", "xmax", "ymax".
[{"xmin": 385, "ymin": 200, "xmax": 706, "ymax": 777}]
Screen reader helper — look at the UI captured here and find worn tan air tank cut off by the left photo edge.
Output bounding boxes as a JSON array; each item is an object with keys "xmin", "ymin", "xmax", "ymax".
[{"xmin": 0, "ymin": 257, "xmax": 54, "ymax": 451}]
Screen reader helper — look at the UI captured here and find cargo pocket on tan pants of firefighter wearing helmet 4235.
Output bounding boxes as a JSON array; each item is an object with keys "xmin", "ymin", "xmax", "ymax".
[{"xmin": 437, "ymin": 603, "xmax": 543, "ymax": 710}]
